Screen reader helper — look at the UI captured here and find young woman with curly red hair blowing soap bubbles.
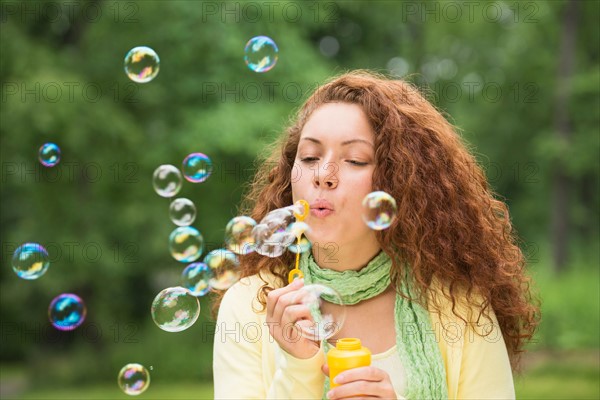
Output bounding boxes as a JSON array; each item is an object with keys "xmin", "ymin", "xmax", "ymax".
[{"xmin": 213, "ymin": 71, "xmax": 539, "ymax": 399}]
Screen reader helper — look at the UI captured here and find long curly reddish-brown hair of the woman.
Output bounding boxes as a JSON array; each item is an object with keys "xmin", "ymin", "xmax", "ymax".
[{"xmin": 215, "ymin": 71, "xmax": 539, "ymax": 367}]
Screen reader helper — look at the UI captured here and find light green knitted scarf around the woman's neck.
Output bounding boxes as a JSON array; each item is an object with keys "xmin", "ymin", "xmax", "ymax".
[{"xmin": 300, "ymin": 251, "xmax": 448, "ymax": 399}]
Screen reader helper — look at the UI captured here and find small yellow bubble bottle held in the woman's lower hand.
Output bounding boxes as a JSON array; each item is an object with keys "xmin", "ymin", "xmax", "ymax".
[{"xmin": 327, "ymin": 338, "xmax": 371, "ymax": 388}]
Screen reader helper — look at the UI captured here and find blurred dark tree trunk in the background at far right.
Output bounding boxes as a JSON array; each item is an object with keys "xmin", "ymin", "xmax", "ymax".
[{"xmin": 552, "ymin": 0, "xmax": 579, "ymax": 273}]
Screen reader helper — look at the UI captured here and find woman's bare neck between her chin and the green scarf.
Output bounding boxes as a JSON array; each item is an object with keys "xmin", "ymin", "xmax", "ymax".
[{"xmin": 312, "ymin": 244, "xmax": 381, "ymax": 271}]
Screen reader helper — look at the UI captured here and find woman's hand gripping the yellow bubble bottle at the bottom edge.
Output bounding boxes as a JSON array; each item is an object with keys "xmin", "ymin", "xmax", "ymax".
[{"xmin": 322, "ymin": 364, "xmax": 402, "ymax": 399}]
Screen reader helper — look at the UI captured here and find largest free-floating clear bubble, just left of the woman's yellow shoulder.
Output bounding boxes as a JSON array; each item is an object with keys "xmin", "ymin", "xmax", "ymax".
[{"xmin": 151, "ymin": 286, "xmax": 200, "ymax": 332}]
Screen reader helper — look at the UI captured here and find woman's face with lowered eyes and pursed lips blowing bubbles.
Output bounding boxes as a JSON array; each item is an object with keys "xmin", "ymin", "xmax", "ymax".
[{"xmin": 292, "ymin": 103, "xmax": 379, "ymax": 252}]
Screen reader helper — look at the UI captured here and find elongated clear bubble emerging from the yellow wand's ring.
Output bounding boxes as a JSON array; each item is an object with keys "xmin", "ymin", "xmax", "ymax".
[{"xmin": 252, "ymin": 204, "xmax": 304, "ymax": 257}]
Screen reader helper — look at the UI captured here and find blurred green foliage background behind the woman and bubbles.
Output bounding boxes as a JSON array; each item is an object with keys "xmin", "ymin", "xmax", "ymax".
[{"xmin": 0, "ymin": 1, "xmax": 600, "ymax": 396}]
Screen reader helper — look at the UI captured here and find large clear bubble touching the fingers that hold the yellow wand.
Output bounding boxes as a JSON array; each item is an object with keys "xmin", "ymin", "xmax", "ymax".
[{"xmin": 294, "ymin": 283, "xmax": 346, "ymax": 341}]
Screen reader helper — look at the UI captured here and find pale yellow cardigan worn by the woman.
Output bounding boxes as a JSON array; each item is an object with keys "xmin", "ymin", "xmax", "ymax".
[{"xmin": 213, "ymin": 274, "xmax": 515, "ymax": 399}]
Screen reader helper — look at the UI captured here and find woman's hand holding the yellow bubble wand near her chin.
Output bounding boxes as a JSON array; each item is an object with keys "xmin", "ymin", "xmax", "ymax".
[{"xmin": 266, "ymin": 279, "xmax": 319, "ymax": 359}]
